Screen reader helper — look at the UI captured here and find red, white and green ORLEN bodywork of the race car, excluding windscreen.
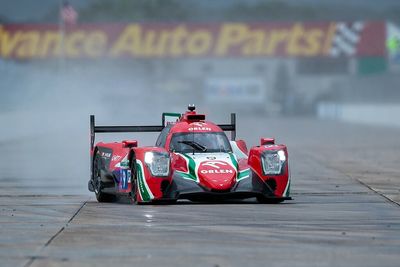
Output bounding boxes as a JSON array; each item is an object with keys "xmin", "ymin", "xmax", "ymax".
[{"xmin": 89, "ymin": 110, "xmax": 290, "ymax": 202}]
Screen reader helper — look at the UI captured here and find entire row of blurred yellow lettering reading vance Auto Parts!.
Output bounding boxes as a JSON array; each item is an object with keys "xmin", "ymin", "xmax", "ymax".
[{"xmin": 0, "ymin": 23, "xmax": 336, "ymax": 59}]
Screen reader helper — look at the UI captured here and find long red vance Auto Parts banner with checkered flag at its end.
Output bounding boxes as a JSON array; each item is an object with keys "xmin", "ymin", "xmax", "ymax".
[{"xmin": 0, "ymin": 22, "xmax": 385, "ymax": 59}]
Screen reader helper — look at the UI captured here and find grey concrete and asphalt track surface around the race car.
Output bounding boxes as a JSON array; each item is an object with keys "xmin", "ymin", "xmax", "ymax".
[{"xmin": 0, "ymin": 116, "xmax": 400, "ymax": 267}]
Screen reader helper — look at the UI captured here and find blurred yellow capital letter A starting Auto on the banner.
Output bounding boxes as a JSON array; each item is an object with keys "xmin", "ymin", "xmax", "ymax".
[{"xmin": 110, "ymin": 24, "xmax": 142, "ymax": 57}]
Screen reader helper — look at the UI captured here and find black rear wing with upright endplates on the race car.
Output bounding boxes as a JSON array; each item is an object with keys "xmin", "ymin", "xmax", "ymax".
[{"xmin": 90, "ymin": 113, "xmax": 236, "ymax": 150}]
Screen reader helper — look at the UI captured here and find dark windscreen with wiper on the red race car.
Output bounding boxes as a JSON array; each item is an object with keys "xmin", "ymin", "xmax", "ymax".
[{"xmin": 169, "ymin": 132, "xmax": 232, "ymax": 153}]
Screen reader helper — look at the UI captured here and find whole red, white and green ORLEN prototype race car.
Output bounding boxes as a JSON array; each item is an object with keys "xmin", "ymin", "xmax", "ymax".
[{"xmin": 88, "ymin": 105, "xmax": 291, "ymax": 204}]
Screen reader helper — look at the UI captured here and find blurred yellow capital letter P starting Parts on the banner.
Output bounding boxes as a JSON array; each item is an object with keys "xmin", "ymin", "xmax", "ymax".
[{"xmin": 215, "ymin": 23, "xmax": 247, "ymax": 56}]
